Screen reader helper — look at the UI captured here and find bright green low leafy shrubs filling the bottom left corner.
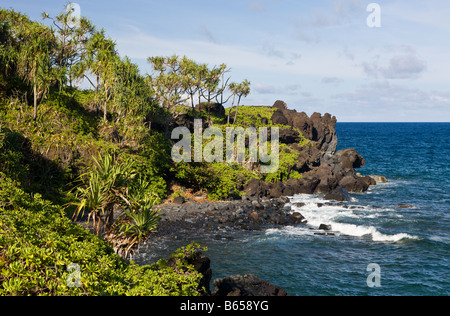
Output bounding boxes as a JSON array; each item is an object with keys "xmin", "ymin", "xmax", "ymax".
[{"xmin": 0, "ymin": 173, "xmax": 202, "ymax": 296}]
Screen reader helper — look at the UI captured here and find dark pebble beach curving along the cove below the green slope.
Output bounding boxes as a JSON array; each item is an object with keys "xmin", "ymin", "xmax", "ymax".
[{"xmin": 152, "ymin": 197, "xmax": 306, "ymax": 239}]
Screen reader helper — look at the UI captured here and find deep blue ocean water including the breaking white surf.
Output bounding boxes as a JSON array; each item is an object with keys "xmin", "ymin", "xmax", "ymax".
[{"xmin": 136, "ymin": 123, "xmax": 450, "ymax": 296}]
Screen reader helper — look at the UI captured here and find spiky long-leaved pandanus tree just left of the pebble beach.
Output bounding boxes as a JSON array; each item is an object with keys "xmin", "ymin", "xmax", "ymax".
[{"xmin": 72, "ymin": 153, "xmax": 160, "ymax": 259}]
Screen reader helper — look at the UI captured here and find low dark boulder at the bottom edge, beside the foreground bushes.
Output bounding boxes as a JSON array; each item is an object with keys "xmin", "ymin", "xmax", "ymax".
[{"xmin": 211, "ymin": 275, "xmax": 289, "ymax": 297}]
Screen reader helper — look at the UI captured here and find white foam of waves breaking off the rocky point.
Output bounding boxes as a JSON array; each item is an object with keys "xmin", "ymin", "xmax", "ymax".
[{"xmin": 278, "ymin": 195, "xmax": 417, "ymax": 242}]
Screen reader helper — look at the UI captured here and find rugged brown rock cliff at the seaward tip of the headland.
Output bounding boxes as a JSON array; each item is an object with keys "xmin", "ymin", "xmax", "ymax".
[{"xmin": 245, "ymin": 101, "xmax": 374, "ymax": 197}]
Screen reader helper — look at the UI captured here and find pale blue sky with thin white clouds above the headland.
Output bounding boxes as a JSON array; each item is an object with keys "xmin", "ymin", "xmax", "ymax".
[{"xmin": 0, "ymin": 0, "xmax": 450, "ymax": 122}]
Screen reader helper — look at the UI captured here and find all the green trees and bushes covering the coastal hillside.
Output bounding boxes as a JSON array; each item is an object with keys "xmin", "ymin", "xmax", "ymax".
[{"xmin": 0, "ymin": 5, "xmax": 307, "ymax": 295}]
